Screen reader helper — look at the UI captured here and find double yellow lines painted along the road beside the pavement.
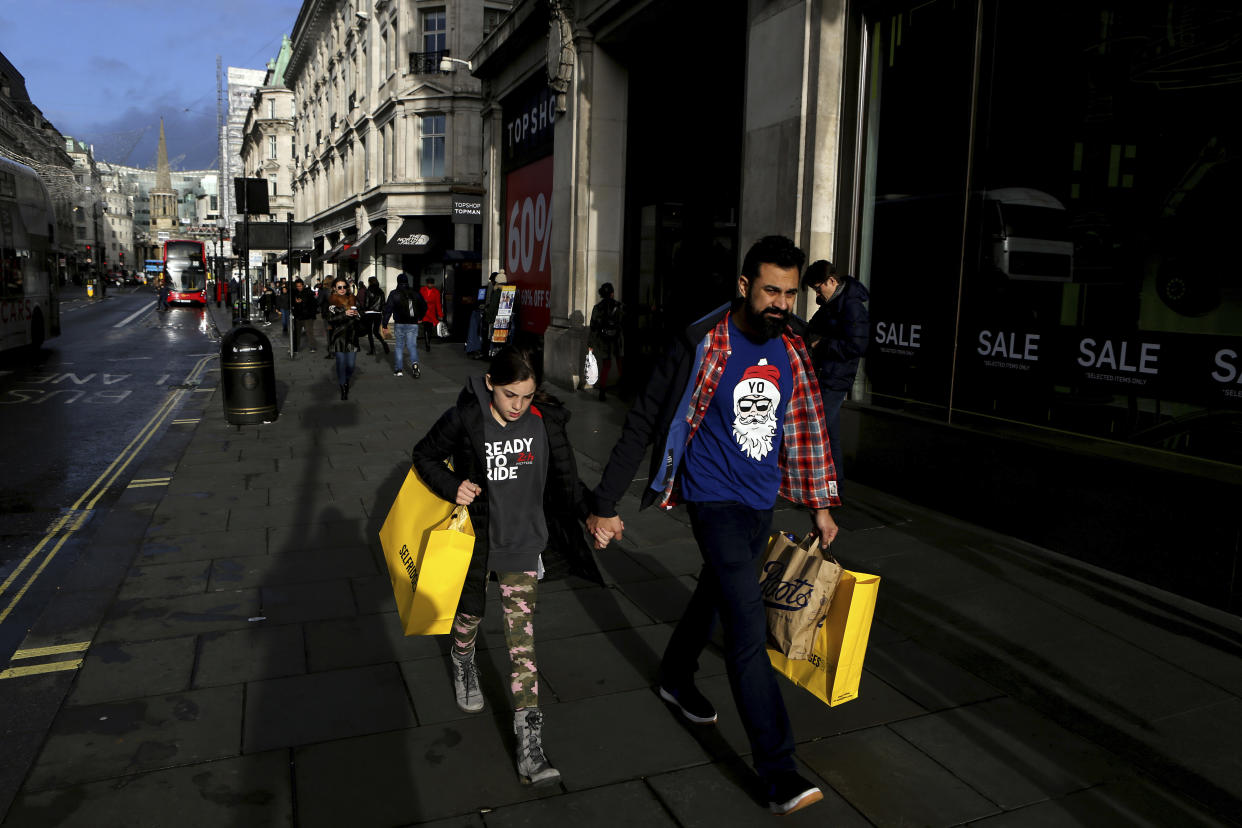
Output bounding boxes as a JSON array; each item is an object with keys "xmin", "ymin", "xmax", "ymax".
[{"xmin": 0, "ymin": 355, "xmax": 215, "ymax": 630}]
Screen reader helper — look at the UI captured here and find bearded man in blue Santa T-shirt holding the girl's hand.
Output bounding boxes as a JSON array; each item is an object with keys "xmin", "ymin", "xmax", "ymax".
[{"xmin": 586, "ymin": 236, "xmax": 841, "ymax": 814}]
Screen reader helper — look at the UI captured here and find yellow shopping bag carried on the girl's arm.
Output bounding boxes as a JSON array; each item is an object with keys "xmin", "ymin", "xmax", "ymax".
[{"xmin": 380, "ymin": 469, "xmax": 474, "ymax": 636}]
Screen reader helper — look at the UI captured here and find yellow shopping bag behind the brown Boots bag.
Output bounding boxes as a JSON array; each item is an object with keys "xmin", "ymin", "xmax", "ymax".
[{"xmin": 768, "ymin": 570, "xmax": 879, "ymax": 708}]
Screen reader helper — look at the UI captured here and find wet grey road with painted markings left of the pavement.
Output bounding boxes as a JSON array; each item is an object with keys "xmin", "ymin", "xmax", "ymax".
[{"xmin": 0, "ymin": 287, "xmax": 219, "ymax": 659}]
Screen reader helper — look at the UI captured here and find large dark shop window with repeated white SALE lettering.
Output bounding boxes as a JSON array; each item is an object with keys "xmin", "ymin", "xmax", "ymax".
[{"xmin": 851, "ymin": 0, "xmax": 1242, "ymax": 464}]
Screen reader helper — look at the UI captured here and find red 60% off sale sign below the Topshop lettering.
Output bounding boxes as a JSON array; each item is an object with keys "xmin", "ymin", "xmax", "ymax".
[{"xmin": 504, "ymin": 155, "xmax": 551, "ymax": 334}]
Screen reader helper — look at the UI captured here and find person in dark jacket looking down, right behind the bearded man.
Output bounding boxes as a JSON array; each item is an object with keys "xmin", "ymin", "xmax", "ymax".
[{"xmin": 802, "ymin": 259, "xmax": 871, "ymax": 479}]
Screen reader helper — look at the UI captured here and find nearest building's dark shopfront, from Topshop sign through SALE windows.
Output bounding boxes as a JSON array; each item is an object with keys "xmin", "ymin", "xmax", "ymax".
[{"xmin": 469, "ymin": 0, "xmax": 1242, "ymax": 610}]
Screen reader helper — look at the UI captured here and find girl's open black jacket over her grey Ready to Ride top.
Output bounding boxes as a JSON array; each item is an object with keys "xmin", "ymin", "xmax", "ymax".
[{"xmin": 414, "ymin": 377, "xmax": 597, "ymax": 616}]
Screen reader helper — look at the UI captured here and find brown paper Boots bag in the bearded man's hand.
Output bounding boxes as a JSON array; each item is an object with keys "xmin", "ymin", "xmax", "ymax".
[{"xmin": 759, "ymin": 533, "xmax": 841, "ymax": 659}]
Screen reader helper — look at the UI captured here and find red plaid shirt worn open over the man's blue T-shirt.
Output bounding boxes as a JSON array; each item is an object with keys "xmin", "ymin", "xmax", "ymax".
[{"xmin": 657, "ymin": 314, "xmax": 841, "ymax": 509}]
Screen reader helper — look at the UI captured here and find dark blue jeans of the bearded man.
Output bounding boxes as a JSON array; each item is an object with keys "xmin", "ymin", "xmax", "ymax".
[{"xmin": 660, "ymin": 500, "xmax": 796, "ymax": 777}]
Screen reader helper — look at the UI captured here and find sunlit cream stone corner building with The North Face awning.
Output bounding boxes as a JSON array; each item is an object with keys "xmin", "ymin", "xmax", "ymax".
[{"xmin": 286, "ymin": 0, "xmax": 509, "ymax": 304}]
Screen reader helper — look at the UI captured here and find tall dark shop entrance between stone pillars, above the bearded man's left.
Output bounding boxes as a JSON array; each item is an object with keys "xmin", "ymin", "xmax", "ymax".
[{"xmin": 609, "ymin": 0, "xmax": 746, "ymax": 387}]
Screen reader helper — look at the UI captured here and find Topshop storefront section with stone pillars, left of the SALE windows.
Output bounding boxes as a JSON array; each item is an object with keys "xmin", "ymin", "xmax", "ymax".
[{"xmin": 472, "ymin": 0, "xmax": 843, "ymax": 385}]
